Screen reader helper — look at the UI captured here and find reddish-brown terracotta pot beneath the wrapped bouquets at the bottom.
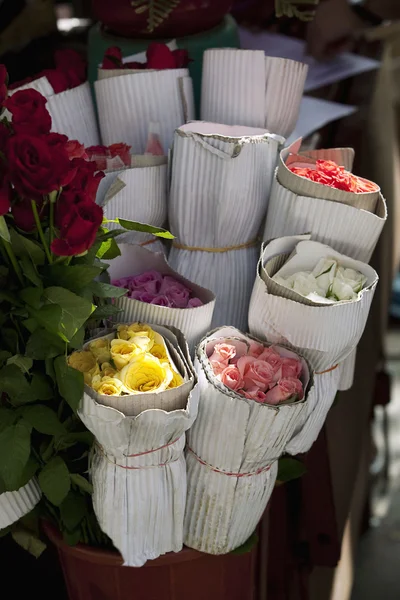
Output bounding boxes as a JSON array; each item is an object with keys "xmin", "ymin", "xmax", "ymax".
[{"xmin": 43, "ymin": 523, "xmax": 257, "ymax": 600}]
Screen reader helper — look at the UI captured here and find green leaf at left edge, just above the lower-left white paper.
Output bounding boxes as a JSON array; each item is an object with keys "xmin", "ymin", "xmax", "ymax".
[{"xmin": 0, "ymin": 419, "xmax": 31, "ymax": 491}]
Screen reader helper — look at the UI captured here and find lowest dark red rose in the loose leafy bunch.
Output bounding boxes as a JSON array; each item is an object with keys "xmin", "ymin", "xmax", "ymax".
[{"xmin": 51, "ymin": 198, "xmax": 103, "ymax": 256}]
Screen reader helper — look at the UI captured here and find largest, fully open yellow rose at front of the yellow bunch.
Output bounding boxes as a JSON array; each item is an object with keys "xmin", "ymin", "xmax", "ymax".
[{"xmin": 119, "ymin": 354, "xmax": 173, "ymax": 393}]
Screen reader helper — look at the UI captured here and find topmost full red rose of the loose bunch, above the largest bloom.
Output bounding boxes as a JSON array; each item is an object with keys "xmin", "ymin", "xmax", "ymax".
[{"xmin": 4, "ymin": 89, "xmax": 51, "ymax": 134}]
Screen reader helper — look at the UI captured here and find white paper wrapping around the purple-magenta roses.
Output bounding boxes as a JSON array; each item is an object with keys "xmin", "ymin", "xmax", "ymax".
[{"xmin": 108, "ymin": 244, "xmax": 215, "ymax": 354}]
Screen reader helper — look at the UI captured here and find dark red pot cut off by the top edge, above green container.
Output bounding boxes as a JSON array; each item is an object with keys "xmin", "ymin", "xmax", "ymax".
[{"xmin": 92, "ymin": 0, "xmax": 233, "ymax": 38}]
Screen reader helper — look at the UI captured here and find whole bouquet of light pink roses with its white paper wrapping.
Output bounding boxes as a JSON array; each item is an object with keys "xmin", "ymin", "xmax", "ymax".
[{"xmin": 184, "ymin": 327, "xmax": 313, "ymax": 554}]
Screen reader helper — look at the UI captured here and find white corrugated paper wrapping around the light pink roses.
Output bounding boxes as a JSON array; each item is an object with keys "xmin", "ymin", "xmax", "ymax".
[{"xmin": 184, "ymin": 327, "xmax": 312, "ymax": 554}]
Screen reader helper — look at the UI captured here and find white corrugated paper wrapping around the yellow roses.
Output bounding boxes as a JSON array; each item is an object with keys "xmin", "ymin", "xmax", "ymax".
[{"xmin": 79, "ymin": 326, "xmax": 198, "ymax": 567}]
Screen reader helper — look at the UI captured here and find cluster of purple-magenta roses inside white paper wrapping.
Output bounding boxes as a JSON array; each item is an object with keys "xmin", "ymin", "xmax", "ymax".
[{"xmin": 112, "ymin": 270, "xmax": 203, "ymax": 308}]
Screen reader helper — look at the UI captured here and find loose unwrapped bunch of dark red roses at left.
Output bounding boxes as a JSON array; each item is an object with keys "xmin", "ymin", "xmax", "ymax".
[{"xmin": 0, "ymin": 65, "xmax": 104, "ymax": 262}]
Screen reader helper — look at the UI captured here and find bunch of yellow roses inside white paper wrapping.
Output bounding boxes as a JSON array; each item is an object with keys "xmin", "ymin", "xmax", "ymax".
[{"xmin": 68, "ymin": 323, "xmax": 184, "ymax": 396}]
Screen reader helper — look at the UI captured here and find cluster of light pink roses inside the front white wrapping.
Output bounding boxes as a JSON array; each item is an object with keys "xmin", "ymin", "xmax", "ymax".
[{"xmin": 209, "ymin": 340, "xmax": 304, "ymax": 404}]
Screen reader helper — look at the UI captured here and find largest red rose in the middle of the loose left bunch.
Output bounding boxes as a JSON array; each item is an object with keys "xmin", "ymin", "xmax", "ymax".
[{"xmin": 7, "ymin": 134, "xmax": 76, "ymax": 200}]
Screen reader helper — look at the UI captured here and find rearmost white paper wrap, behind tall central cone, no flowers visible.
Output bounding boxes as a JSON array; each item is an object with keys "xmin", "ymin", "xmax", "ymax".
[{"xmin": 201, "ymin": 48, "xmax": 308, "ymax": 137}]
